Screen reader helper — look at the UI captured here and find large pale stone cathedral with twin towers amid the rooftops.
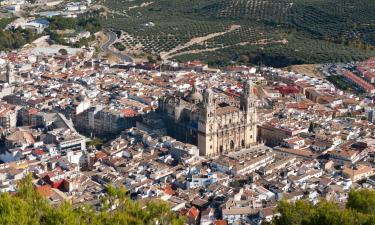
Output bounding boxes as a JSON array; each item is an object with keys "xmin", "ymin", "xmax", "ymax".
[{"xmin": 157, "ymin": 80, "xmax": 257, "ymax": 156}]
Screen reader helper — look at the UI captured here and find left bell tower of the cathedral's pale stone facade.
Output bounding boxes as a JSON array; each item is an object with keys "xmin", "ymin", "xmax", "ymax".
[{"xmin": 198, "ymin": 89, "xmax": 217, "ymax": 155}]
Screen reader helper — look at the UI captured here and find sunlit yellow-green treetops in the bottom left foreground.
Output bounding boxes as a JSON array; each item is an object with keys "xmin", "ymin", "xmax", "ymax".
[{"xmin": 0, "ymin": 176, "xmax": 183, "ymax": 225}]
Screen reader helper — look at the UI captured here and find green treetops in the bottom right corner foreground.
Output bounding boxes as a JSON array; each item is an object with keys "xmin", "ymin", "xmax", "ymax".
[{"xmin": 272, "ymin": 190, "xmax": 375, "ymax": 225}]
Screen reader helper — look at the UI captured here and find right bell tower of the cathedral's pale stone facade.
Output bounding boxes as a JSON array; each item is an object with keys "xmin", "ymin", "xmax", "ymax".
[{"xmin": 240, "ymin": 80, "xmax": 257, "ymax": 147}]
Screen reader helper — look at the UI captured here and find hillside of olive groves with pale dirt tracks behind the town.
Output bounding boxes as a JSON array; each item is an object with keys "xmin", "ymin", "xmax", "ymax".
[{"xmin": 99, "ymin": 0, "xmax": 375, "ymax": 66}]
